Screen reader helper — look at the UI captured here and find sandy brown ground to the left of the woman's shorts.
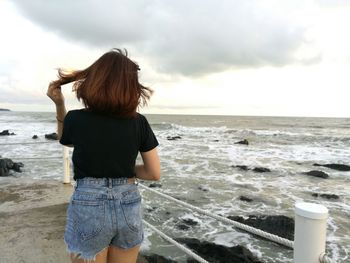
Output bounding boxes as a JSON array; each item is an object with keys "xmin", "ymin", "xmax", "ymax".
[{"xmin": 0, "ymin": 177, "xmax": 147, "ymax": 263}]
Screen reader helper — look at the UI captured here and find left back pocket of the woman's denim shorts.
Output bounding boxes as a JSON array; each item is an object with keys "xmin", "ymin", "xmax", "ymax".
[{"xmin": 70, "ymin": 199, "xmax": 105, "ymax": 240}]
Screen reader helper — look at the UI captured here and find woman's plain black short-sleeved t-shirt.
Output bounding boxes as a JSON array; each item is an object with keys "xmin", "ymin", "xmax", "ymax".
[{"xmin": 60, "ymin": 109, "xmax": 158, "ymax": 180}]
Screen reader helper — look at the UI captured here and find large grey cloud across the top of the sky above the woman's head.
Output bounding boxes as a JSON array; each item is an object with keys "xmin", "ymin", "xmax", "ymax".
[{"xmin": 10, "ymin": 0, "xmax": 319, "ymax": 75}]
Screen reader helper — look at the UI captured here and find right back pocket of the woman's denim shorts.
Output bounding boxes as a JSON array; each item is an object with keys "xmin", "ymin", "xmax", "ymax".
[{"xmin": 120, "ymin": 190, "xmax": 142, "ymax": 232}]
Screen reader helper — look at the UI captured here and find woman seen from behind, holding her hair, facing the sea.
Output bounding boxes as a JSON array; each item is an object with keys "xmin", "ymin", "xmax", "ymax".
[{"xmin": 47, "ymin": 49, "xmax": 160, "ymax": 263}]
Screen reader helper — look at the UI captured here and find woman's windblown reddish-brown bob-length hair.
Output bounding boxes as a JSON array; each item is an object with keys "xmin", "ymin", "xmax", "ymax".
[{"xmin": 58, "ymin": 48, "xmax": 153, "ymax": 118}]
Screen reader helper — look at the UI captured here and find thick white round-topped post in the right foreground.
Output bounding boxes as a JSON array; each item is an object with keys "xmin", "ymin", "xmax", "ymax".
[{"xmin": 294, "ymin": 203, "xmax": 328, "ymax": 263}]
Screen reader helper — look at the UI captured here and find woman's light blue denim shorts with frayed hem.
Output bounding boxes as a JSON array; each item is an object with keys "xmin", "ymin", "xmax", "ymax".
[{"xmin": 64, "ymin": 177, "xmax": 144, "ymax": 261}]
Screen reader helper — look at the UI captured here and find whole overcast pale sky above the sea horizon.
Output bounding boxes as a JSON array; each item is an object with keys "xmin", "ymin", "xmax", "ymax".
[{"xmin": 0, "ymin": 0, "xmax": 350, "ymax": 117}]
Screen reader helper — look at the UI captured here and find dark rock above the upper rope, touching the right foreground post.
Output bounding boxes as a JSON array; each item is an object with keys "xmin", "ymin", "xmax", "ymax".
[{"xmin": 228, "ymin": 215, "xmax": 294, "ymax": 240}]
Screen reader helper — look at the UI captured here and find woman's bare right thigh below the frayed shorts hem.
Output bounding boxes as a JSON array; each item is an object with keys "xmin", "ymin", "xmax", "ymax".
[{"xmin": 107, "ymin": 246, "xmax": 140, "ymax": 263}]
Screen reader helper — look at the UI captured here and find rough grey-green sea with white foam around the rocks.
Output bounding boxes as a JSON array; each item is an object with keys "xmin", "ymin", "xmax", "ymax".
[{"xmin": 0, "ymin": 112, "xmax": 350, "ymax": 262}]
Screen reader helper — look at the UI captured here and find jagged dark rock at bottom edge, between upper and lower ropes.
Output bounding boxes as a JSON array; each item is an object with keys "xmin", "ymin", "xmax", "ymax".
[{"xmin": 176, "ymin": 238, "xmax": 261, "ymax": 263}]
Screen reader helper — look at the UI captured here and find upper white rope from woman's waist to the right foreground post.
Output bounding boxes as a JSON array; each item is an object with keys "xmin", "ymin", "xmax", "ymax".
[{"xmin": 139, "ymin": 183, "xmax": 294, "ymax": 248}]
